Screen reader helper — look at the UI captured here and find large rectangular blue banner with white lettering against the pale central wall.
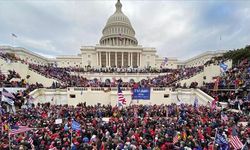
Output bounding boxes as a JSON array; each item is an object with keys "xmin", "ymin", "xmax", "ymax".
[{"xmin": 132, "ymin": 88, "xmax": 150, "ymax": 100}]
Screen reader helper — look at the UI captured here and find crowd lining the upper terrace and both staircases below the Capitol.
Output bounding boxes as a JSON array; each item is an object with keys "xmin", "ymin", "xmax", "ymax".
[{"xmin": 0, "ymin": 53, "xmax": 204, "ymax": 87}]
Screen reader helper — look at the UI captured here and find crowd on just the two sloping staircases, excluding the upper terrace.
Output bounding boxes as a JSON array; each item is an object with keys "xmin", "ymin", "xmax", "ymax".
[{"xmin": 29, "ymin": 64, "xmax": 204, "ymax": 87}]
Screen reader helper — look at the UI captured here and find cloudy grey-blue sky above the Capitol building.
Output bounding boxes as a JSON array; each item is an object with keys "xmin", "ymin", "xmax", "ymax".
[{"xmin": 0, "ymin": 0, "xmax": 250, "ymax": 59}]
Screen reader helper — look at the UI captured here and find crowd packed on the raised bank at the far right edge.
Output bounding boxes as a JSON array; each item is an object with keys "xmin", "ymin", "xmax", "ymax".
[{"xmin": 201, "ymin": 59, "xmax": 250, "ymax": 114}]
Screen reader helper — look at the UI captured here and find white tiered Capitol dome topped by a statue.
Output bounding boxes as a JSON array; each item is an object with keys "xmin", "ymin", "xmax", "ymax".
[{"xmin": 100, "ymin": 0, "xmax": 138, "ymax": 46}]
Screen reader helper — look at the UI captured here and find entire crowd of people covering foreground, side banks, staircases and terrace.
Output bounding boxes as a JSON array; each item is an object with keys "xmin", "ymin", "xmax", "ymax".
[{"xmin": 0, "ymin": 53, "xmax": 250, "ymax": 150}]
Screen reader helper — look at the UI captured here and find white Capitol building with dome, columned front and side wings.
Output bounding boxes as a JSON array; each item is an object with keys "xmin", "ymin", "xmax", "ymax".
[{"xmin": 0, "ymin": 0, "xmax": 224, "ymax": 69}]
